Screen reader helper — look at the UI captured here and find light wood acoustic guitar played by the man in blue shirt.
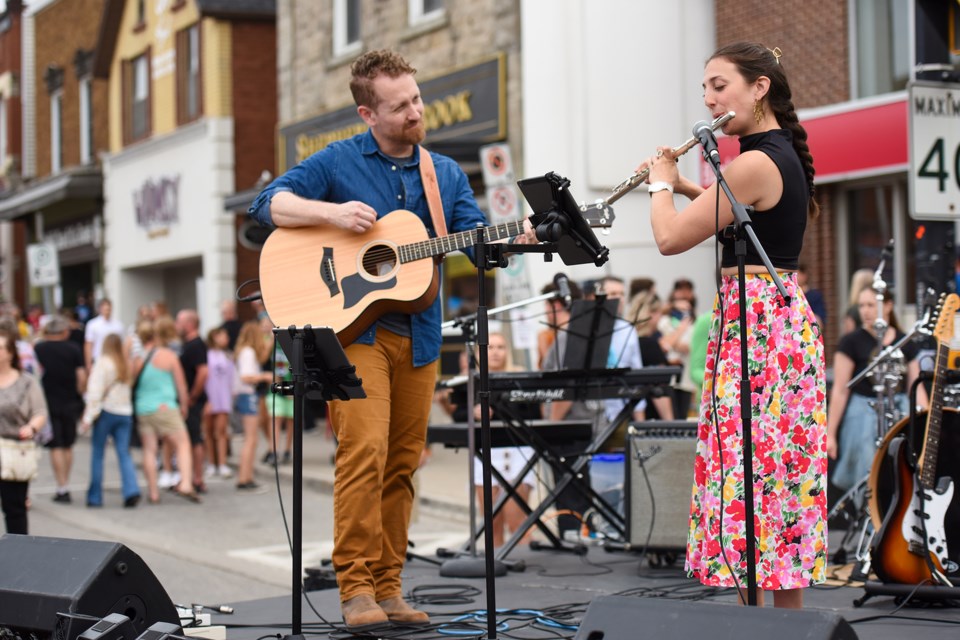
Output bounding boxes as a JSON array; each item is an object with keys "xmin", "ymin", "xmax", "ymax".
[{"xmin": 260, "ymin": 203, "xmax": 614, "ymax": 346}]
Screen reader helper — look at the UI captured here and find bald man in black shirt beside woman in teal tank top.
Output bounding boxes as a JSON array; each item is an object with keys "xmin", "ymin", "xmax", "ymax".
[{"xmin": 176, "ymin": 309, "xmax": 207, "ymax": 493}]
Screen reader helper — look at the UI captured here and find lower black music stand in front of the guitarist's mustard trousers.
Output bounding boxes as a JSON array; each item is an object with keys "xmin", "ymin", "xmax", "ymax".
[{"xmin": 273, "ymin": 325, "xmax": 367, "ymax": 640}]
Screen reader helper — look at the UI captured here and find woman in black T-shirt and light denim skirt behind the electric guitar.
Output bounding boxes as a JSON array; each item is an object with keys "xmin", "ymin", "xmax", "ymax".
[{"xmin": 827, "ymin": 288, "xmax": 928, "ymax": 490}]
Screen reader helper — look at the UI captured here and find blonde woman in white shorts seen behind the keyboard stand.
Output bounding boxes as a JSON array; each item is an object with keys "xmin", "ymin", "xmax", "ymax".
[{"xmin": 439, "ymin": 332, "xmax": 540, "ymax": 547}]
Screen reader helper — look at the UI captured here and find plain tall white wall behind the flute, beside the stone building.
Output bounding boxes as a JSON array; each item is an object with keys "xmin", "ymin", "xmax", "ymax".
[{"xmin": 517, "ymin": 0, "xmax": 715, "ymax": 312}]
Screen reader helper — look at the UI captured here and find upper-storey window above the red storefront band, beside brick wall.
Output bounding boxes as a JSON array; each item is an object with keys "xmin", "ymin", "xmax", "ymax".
[{"xmin": 851, "ymin": 0, "xmax": 913, "ymax": 98}]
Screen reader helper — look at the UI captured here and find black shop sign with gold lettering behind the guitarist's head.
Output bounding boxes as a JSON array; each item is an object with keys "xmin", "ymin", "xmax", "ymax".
[{"xmin": 279, "ymin": 53, "xmax": 507, "ymax": 173}]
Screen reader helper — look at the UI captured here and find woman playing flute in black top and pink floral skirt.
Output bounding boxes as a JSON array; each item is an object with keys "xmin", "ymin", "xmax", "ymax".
[{"xmin": 639, "ymin": 43, "xmax": 827, "ymax": 608}]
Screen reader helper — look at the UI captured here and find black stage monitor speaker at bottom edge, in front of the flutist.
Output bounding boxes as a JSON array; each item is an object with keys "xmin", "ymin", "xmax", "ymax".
[{"xmin": 574, "ymin": 596, "xmax": 857, "ymax": 640}]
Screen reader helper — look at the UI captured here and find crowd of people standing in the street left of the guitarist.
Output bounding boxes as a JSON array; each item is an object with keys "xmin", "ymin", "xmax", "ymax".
[{"xmin": 0, "ymin": 299, "xmax": 310, "ymax": 533}]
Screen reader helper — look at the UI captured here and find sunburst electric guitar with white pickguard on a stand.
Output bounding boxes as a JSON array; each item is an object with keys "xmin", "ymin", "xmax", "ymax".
[{"xmin": 871, "ymin": 293, "xmax": 960, "ymax": 584}]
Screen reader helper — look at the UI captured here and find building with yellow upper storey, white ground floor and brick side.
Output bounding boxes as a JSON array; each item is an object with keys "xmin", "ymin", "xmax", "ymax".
[{"xmin": 94, "ymin": 0, "xmax": 277, "ymax": 329}]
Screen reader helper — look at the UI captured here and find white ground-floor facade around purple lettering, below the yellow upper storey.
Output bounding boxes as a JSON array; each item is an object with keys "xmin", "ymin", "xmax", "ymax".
[{"xmin": 104, "ymin": 118, "xmax": 236, "ymax": 330}]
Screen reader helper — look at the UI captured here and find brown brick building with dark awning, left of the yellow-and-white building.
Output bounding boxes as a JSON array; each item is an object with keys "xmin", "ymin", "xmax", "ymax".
[{"xmin": 0, "ymin": 0, "xmax": 107, "ymax": 311}]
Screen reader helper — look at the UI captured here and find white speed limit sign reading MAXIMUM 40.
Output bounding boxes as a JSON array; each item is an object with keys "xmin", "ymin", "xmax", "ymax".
[{"xmin": 908, "ymin": 82, "xmax": 960, "ymax": 220}]
